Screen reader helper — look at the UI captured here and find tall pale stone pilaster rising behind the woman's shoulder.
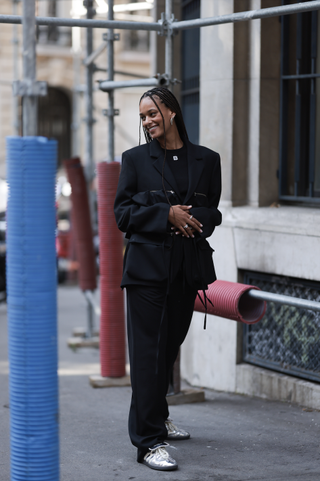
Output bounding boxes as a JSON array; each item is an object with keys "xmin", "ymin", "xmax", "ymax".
[{"xmin": 200, "ymin": 0, "xmax": 233, "ymax": 205}]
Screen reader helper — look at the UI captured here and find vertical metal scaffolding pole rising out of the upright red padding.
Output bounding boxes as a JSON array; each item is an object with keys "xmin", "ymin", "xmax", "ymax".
[{"xmin": 106, "ymin": 0, "xmax": 115, "ymax": 162}]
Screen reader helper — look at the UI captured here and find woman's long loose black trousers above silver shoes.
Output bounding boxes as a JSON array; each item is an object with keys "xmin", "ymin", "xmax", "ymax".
[{"xmin": 127, "ymin": 275, "xmax": 197, "ymax": 462}]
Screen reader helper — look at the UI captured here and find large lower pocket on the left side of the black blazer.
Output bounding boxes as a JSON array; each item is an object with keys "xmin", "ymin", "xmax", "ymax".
[{"xmin": 124, "ymin": 235, "xmax": 168, "ymax": 282}]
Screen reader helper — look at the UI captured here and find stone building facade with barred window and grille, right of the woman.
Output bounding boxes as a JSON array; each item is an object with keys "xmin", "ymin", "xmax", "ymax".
[{"xmin": 182, "ymin": 0, "xmax": 320, "ymax": 407}]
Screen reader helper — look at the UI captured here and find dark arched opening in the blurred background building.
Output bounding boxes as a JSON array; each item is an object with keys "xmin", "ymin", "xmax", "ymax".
[{"xmin": 38, "ymin": 87, "xmax": 71, "ymax": 166}]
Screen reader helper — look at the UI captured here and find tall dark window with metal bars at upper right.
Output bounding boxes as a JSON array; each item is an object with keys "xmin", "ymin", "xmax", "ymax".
[{"xmin": 279, "ymin": 0, "xmax": 320, "ymax": 203}]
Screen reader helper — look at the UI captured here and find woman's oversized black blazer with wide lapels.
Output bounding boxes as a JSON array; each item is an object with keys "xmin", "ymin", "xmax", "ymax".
[{"xmin": 114, "ymin": 140, "xmax": 221, "ymax": 289}]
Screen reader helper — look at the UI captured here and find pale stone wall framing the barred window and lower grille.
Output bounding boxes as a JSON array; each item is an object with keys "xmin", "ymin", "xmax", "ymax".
[{"xmin": 181, "ymin": 0, "xmax": 320, "ymax": 407}]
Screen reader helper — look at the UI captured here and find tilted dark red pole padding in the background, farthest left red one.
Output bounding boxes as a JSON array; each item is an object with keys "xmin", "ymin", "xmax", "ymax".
[{"xmin": 64, "ymin": 157, "xmax": 97, "ymax": 291}]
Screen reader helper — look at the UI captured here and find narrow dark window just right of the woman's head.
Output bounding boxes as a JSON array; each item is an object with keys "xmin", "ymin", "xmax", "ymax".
[{"xmin": 181, "ymin": 0, "xmax": 200, "ymax": 144}]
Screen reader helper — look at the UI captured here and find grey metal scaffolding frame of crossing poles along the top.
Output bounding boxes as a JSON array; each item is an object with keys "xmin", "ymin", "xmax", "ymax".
[{"xmin": 0, "ymin": 0, "xmax": 320, "ymax": 166}]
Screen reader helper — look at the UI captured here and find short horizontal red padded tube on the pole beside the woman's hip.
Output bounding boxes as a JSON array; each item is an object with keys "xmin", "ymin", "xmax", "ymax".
[{"xmin": 194, "ymin": 280, "xmax": 267, "ymax": 324}]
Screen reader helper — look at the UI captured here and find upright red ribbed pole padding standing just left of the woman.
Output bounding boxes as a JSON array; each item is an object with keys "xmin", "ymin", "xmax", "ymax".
[{"xmin": 98, "ymin": 162, "xmax": 126, "ymax": 377}]
